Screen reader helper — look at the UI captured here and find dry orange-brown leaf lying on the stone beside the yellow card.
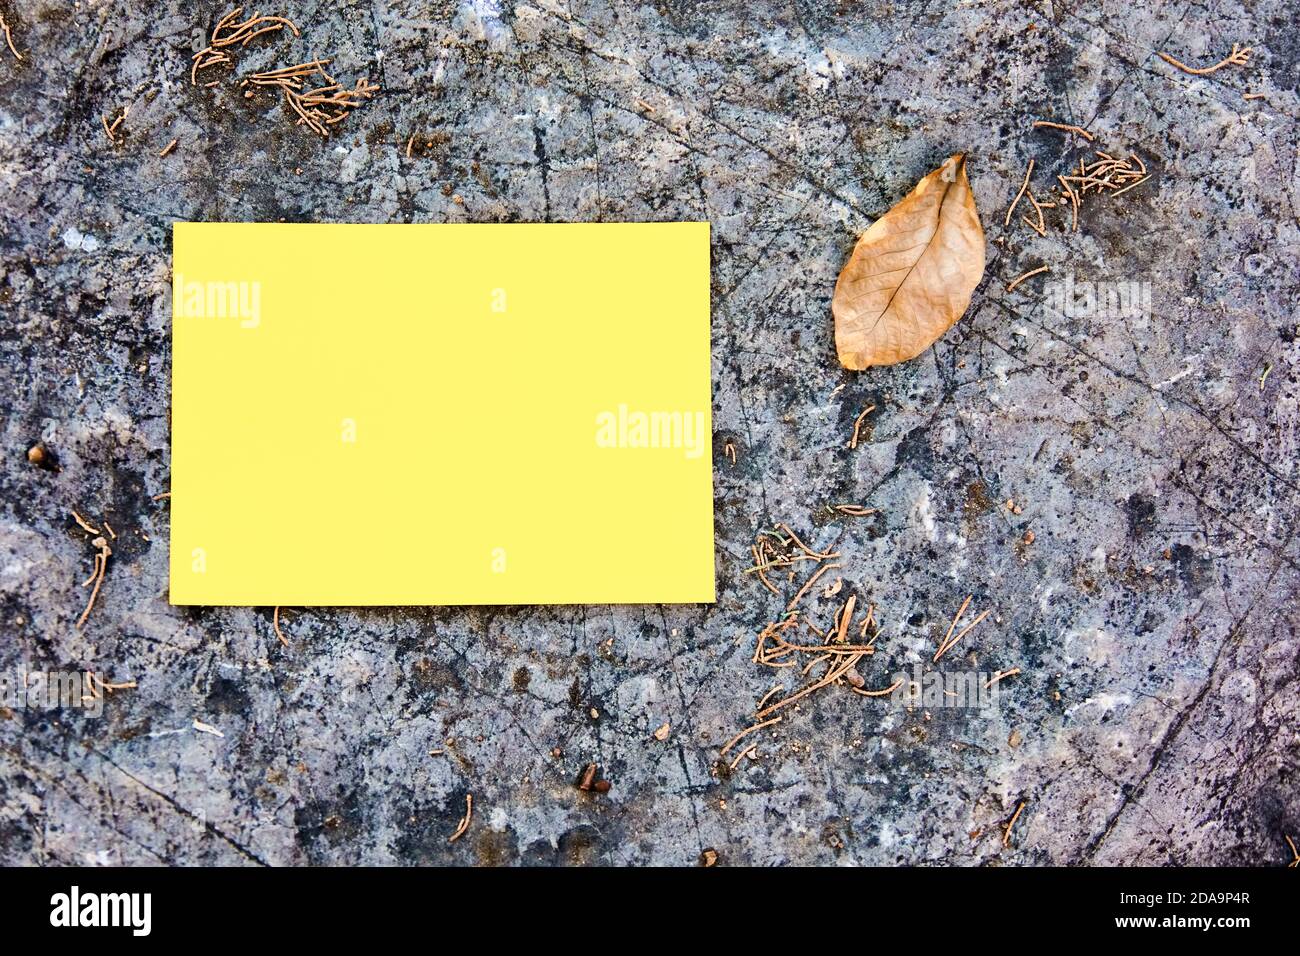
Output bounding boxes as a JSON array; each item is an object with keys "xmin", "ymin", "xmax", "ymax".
[{"xmin": 831, "ymin": 153, "xmax": 984, "ymax": 369}]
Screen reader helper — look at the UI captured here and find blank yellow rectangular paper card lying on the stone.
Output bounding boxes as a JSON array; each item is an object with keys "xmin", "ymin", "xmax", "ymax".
[{"xmin": 170, "ymin": 222, "xmax": 714, "ymax": 605}]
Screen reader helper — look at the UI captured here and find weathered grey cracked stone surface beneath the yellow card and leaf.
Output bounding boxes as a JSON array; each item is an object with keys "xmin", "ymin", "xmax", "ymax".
[{"xmin": 0, "ymin": 0, "xmax": 1300, "ymax": 865}]
